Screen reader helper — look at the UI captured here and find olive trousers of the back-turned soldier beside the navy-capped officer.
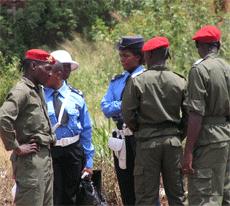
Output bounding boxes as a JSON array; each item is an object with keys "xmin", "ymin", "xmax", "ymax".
[{"xmin": 134, "ymin": 136, "xmax": 184, "ymax": 206}]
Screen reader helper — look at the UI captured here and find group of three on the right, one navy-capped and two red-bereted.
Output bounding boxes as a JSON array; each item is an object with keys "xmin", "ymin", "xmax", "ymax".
[{"xmin": 101, "ymin": 25, "xmax": 230, "ymax": 205}]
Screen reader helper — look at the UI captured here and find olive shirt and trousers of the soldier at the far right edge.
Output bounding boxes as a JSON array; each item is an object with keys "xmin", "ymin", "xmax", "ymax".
[{"xmin": 185, "ymin": 53, "xmax": 230, "ymax": 205}]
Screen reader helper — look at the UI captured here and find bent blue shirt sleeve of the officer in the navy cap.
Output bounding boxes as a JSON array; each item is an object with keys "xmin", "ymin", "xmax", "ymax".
[{"xmin": 101, "ymin": 83, "xmax": 121, "ymax": 118}]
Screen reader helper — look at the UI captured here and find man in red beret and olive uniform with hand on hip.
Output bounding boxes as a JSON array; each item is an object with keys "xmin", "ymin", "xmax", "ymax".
[{"xmin": 0, "ymin": 49, "xmax": 55, "ymax": 206}]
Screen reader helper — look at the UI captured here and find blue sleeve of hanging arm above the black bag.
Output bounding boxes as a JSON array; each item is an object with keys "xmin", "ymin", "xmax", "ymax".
[{"xmin": 80, "ymin": 100, "xmax": 94, "ymax": 168}]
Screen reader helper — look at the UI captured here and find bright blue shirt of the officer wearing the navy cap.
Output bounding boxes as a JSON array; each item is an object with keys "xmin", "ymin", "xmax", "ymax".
[{"xmin": 101, "ymin": 66, "xmax": 144, "ymax": 118}]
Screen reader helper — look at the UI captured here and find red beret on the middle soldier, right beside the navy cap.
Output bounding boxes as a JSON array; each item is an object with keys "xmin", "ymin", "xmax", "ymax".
[{"xmin": 142, "ymin": 36, "xmax": 169, "ymax": 51}]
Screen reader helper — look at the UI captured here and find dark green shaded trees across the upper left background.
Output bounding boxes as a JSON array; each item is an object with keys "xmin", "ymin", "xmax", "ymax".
[{"xmin": 0, "ymin": 0, "xmax": 144, "ymax": 60}]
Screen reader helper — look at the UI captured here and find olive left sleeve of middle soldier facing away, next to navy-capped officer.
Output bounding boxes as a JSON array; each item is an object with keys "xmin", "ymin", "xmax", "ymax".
[{"xmin": 122, "ymin": 79, "xmax": 139, "ymax": 131}]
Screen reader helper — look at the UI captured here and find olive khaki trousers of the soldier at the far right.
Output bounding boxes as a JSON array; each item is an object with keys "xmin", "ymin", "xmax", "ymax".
[{"xmin": 188, "ymin": 142, "xmax": 230, "ymax": 206}]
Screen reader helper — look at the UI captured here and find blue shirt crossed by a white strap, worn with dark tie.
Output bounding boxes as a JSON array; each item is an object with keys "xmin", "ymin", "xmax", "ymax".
[{"xmin": 45, "ymin": 81, "xmax": 94, "ymax": 168}]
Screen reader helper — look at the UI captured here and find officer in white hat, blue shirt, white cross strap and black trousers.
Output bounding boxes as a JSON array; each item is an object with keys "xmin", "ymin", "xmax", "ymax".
[{"xmin": 45, "ymin": 51, "xmax": 94, "ymax": 205}]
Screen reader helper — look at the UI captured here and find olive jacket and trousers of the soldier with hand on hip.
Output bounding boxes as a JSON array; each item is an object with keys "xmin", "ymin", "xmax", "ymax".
[{"xmin": 0, "ymin": 77, "xmax": 55, "ymax": 206}]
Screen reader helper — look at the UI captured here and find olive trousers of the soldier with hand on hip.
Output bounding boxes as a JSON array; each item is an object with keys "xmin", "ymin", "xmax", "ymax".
[{"xmin": 11, "ymin": 147, "xmax": 53, "ymax": 206}]
